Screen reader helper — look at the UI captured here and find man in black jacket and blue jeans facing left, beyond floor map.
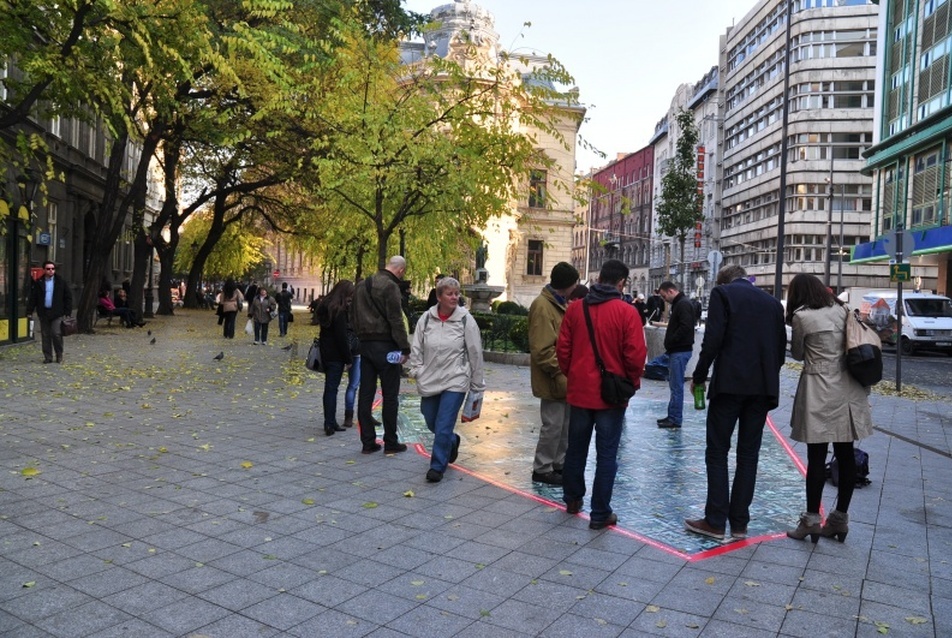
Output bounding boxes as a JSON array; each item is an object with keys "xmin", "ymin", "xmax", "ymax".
[{"xmin": 658, "ymin": 281, "xmax": 695, "ymax": 429}]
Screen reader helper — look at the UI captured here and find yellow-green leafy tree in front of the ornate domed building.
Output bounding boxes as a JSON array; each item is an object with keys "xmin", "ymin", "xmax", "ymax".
[{"xmin": 310, "ymin": 28, "xmax": 574, "ymax": 278}]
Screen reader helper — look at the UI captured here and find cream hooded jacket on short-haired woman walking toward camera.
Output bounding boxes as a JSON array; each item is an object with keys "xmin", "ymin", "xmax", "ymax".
[{"xmin": 407, "ymin": 306, "xmax": 486, "ymax": 397}]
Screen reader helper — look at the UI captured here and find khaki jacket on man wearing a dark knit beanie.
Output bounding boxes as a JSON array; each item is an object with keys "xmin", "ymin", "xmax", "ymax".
[{"xmin": 529, "ymin": 286, "xmax": 566, "ymax": 401}]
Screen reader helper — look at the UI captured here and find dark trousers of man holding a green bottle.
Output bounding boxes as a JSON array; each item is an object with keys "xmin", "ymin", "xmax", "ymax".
[{"xmin": 704, "ymin": 394, "xmax": 771, "ymax": 529}]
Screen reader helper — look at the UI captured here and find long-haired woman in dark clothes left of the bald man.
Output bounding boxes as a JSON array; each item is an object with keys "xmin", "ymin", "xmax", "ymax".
[{"xmin": 317, "ymin": 279, "xmax": 360, "ymax": 436}]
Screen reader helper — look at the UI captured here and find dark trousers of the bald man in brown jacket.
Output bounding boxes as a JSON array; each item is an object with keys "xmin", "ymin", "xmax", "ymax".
[{"xmin": 357, "ymin": 341, "xmax": 402, "ymax": 446}]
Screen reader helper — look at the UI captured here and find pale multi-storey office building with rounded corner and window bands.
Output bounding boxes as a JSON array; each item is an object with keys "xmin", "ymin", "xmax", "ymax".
[{"xmin": 713, "ymin": 0, "xmax": 884, "ymax": 294}]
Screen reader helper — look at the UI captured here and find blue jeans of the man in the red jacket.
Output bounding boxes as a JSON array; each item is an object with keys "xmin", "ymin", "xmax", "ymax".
[{"xmin": 562, "ymin": 405, "xmax": 625, "ymax": 522}]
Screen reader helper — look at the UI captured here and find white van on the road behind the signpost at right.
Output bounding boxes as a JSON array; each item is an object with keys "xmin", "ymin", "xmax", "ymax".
[{"xmin": 854, "ymin": 290, "xmax": 952, "ymax": 356}]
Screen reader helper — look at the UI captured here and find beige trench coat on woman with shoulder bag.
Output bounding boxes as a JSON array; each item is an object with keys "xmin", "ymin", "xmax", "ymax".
[{"xmin": 790, "ymin": 304, "xmax": 873, "ymax": 443}]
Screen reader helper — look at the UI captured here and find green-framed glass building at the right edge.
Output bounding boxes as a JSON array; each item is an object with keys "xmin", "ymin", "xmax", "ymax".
[{"xmin": 853, "ymin": 0, "xmax": 952, "ymax": 295}]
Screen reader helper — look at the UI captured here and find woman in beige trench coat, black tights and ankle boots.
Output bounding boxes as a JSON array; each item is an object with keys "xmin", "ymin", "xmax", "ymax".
[{"xmin": 787, "ymin": 274, "xmax": 873, "ymax": 543}]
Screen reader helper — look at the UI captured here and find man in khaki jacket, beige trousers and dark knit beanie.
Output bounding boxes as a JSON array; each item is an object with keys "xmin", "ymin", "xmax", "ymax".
[{"xmin": 528, "ymin": 261, "xmax": 579, "ymax": 485}]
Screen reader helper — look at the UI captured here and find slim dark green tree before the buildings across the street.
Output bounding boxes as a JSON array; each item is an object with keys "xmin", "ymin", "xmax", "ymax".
[{"xmin": 658, "ymin": 108, "xmax": 704, "ymax": 290}]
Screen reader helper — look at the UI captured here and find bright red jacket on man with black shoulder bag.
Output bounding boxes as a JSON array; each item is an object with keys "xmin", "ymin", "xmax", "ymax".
[{"xmin": 556, "ymin": 284, "xmax": 648, "ymax": 410}]
